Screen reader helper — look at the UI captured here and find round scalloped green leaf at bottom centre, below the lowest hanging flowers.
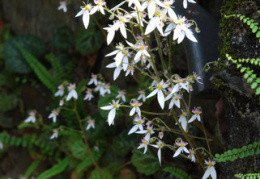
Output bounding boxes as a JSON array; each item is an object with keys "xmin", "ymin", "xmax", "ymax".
[{"xmin": 131, "ymin": 150, "xmax": 160, "ymax": 175}]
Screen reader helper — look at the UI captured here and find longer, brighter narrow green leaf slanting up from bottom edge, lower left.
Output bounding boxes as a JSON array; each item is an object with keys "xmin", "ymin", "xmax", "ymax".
[{"xmin": 37, "ymin": 157, "xmax": 69, "ymax": 179}]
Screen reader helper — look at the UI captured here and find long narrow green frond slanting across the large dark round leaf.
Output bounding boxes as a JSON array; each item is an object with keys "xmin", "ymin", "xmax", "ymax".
[{"xmin": 16, "ymin": 45, "xmax": 58, "ymax": 93}]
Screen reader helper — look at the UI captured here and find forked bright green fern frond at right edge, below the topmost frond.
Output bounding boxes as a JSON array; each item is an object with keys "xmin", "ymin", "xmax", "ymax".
[{"xmin": 226, "ymin": 54, "xmax": 260, "ymax": 95}]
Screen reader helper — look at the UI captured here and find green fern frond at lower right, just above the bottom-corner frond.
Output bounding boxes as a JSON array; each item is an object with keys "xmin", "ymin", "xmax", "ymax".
[{"xmin": 215, "ymin": 142, "xmax": 260, "ymax": 163}]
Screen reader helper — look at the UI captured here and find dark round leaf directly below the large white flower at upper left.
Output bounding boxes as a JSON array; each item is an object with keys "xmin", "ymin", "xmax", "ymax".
[{"xmin": 76, "ymin": 24, "xmax": 104, "ymax": 55}]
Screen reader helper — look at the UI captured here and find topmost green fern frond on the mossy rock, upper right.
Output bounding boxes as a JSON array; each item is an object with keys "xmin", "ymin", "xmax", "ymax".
[{"xmin": 225, "ymin": 14, "xmax": 260, "ymax": 43}]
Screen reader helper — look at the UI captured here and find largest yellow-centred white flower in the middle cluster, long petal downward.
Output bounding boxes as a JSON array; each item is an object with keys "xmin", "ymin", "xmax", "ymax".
[{"xmin": 146, "ymin": 80, "xmax": 168, "ymax": 109}]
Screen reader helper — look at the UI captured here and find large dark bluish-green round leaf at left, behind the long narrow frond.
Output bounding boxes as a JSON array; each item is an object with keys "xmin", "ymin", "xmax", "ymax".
[{"xmin": 4, "ymin": 35, "xmax": 46, "ymax": 73}]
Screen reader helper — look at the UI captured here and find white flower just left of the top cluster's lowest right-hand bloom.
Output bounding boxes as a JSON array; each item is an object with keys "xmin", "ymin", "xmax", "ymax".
[{"xmin": 145, "ymin": 7, "xmax": 166, "ymax": 36}]
